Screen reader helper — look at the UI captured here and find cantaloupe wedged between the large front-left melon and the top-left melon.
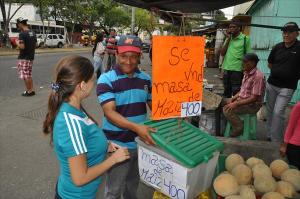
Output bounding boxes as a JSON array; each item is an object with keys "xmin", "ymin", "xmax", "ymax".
[{"xmin": 231, "ymin": 164, "xmax": 252, "ymax": 185}]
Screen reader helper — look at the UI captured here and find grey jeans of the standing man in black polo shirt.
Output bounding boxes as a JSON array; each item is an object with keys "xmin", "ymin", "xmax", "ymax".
[{"xmin": 266, "ymin": 83, "xmax": 294, "ymax": 142}]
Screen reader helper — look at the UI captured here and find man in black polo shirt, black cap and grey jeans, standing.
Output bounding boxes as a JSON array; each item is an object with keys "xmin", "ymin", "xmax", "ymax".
[{"xmin": 266, "ymin": 22, "xmax": 300, "ymax": 142}]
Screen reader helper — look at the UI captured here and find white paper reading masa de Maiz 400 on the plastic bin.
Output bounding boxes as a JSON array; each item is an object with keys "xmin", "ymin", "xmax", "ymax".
[{"xmin": 138, "ymin": 146, "xmax": 188, "ymax": 199}]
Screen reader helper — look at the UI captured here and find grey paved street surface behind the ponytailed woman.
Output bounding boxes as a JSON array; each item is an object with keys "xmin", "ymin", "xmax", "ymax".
[{"xmin": 0, "ymin": 52, "xmax": 152, "ymax": 199}]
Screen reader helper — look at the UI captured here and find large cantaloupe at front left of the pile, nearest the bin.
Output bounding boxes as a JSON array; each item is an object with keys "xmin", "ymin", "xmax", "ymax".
[{"xmin": 213, "ymin": 174, "xmax": 239, "ymax": 197}]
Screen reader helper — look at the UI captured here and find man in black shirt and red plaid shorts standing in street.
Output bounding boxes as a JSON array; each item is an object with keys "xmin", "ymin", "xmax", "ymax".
[{"xmin": 17, "ymin": 17, "xmax": 36, "ymax": 97}]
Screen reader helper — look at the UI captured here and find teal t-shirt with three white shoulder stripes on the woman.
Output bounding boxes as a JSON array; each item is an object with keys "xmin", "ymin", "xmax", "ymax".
[{"xmin": 53, "ymin": 103, "xmax": 107, "ymax": 199}]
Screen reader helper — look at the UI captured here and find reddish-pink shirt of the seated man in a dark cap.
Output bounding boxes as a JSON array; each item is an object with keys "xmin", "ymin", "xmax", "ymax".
[{"xmin": 239, "ymin": 68, "xmax": 266, "ymax": 102}]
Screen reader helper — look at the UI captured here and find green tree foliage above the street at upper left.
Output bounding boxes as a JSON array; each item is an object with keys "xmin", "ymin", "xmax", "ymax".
[{"xmin": 0, "ymin": 0, "xmax": 162, "ymax": 45}]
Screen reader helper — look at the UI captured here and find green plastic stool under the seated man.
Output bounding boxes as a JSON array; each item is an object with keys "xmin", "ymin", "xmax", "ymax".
[{"xmin": 224, "ymin": 114, "xmax": 257, "ymax": 140}]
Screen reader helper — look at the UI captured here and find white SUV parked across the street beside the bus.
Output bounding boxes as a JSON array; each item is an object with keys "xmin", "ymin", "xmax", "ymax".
[{"xmin": 37, "ymin": 34, "xmax": 66, "ymax": 48}]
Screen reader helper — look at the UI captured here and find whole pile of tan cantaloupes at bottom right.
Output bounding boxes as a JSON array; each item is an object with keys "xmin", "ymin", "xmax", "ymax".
[{"xmin": 213, "ymin": 154, "xmax": 300, "ymax": 199}]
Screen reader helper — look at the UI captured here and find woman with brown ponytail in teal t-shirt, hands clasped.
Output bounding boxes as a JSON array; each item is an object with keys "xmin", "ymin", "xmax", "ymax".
[{"xmin": 43, "ymin": 56, "xmax": 129, "ymax": 199}]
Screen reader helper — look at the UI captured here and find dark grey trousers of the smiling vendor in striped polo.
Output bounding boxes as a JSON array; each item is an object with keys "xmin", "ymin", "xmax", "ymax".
[{"xmin": 104, "ymin": 149, "xmax": 140, "ymax": 199}]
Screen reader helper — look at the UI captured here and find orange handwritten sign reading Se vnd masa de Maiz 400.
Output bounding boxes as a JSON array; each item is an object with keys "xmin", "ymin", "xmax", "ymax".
[{"xmin": 152, "ymin": 36, "xmax": 205, "ymax": 120}]
